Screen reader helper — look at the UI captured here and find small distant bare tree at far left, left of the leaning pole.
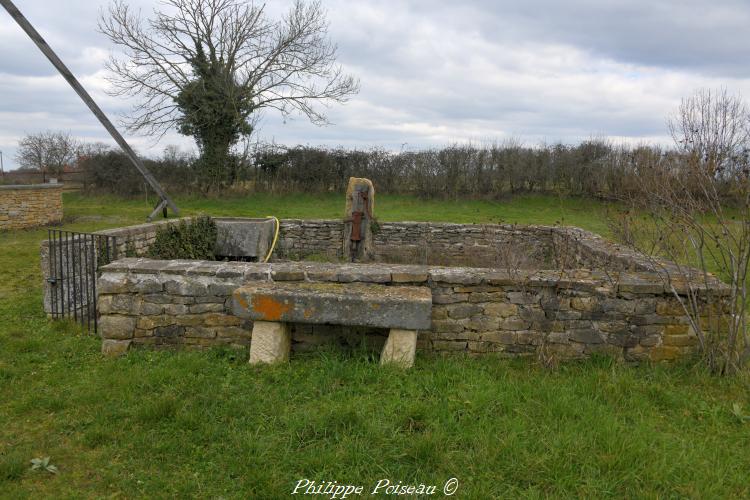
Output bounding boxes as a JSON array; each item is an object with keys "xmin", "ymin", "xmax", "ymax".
[{"xmin": 16, "ymin": 131, "xmax": 78, "ymax": 180}]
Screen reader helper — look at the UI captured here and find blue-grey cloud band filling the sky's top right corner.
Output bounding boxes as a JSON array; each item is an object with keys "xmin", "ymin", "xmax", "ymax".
[{"xmin": 419, "ymin": 0, "xmax": 750, "ymax": 76}]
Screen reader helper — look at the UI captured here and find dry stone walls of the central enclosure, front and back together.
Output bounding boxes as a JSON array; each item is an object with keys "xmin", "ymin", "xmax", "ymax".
[{"xmin": 42, "ymin": 219, "xmax": 726, "ymax": 361}]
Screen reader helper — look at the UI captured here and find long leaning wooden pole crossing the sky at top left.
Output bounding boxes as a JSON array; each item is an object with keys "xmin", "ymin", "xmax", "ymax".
[{"xmin": 0, "ymin": 0, "xmax": 180, "ymax": 220}]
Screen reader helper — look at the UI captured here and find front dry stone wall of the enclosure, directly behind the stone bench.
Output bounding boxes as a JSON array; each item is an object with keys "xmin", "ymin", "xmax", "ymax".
[{"xmin": 97, "ymin": 259, "xmax": 724, "ymax": 361}]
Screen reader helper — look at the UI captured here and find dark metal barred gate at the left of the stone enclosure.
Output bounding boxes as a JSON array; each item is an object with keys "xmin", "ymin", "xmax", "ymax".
[{"xmin": 47, "ymin": 229, "xmax": 117, "ymax": 332}]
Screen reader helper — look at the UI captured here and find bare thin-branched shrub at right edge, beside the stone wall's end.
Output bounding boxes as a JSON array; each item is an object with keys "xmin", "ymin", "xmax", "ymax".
[{"xmin": 615, "ymin": 91, "xmax": 750, "ymax": 374}]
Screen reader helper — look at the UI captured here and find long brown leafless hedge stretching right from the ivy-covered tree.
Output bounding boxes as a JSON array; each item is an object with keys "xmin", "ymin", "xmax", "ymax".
[{"xmin": 250, "ymin": 140, "xmax": 648, "ymax": 199}]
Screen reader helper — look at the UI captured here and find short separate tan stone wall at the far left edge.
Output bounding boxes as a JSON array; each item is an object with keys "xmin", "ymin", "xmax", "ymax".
[{"xmin": 0, "ymin": 184, "xmax": 63, "ymax": 231}]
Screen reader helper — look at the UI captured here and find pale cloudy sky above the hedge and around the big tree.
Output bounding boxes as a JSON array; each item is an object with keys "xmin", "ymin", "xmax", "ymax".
[{"xmin": 0, "ymin": 0, "xmax": 750, "ymax": 170}]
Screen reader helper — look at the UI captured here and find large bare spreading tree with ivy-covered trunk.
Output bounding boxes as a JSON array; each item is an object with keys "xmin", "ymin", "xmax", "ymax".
[{"xmin": 99, "ymin": 0, "xmax": 359, "ymax": 188}]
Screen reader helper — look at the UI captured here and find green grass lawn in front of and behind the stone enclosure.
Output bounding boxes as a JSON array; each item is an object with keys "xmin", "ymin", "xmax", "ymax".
[{"xmin": 0, "ymin": 194, "xmax": 750, "ymax": 498}]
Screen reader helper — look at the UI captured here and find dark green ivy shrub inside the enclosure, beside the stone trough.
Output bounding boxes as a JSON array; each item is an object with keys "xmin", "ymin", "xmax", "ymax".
[{"xmin": 147, "ymin": 215, "xmax": 216, "ymax": 260}]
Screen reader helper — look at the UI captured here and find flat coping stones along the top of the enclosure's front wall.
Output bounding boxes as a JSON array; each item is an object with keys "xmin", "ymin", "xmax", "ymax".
[{"xmin": 102, "ymin": 258, "xmax": 729, "ymax": 295}]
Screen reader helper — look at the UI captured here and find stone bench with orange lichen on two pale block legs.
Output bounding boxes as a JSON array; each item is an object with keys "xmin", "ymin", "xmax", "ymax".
[{"xmin": 232, "ymin": 282, "xmax": 432, "ymax": 368}]
